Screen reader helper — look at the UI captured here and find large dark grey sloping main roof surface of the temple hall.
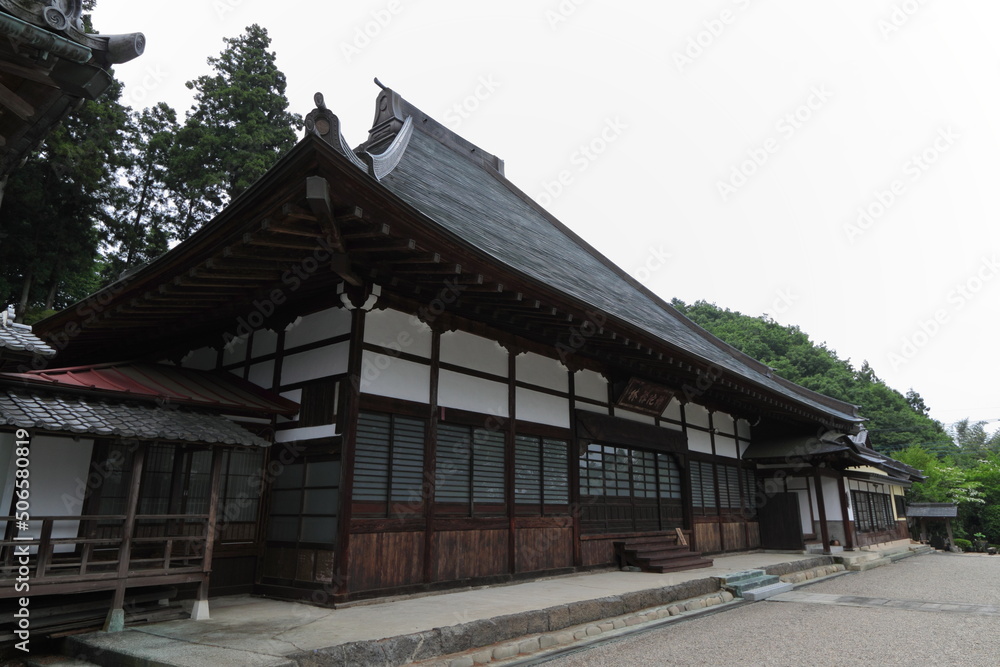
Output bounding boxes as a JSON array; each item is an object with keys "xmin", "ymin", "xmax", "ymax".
[{"xmin": 382, "ymin": 123, "xmax": 861, "ymax": 423}]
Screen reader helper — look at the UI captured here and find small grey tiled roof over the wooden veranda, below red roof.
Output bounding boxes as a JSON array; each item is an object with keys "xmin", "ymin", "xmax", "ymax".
[{"xmin": 0, "ymin": 389, "xmax": 269, "ymax": 447}]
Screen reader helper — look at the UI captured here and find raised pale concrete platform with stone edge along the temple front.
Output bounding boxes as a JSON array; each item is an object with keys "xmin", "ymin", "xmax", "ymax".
[{"xmin": 52, "ymin": 552, "xmax": 860, "ymax": 667}]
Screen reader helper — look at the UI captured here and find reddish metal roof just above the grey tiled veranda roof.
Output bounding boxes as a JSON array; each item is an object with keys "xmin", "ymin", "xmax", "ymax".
[{"xmin": 0, "ymin": 362, "xmax": 299, "ymax": 416}]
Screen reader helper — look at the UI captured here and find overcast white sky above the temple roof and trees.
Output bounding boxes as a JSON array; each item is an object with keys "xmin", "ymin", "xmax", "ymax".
[{"xmin": 94, "ymin": 0, "xmax": 1000, "ymax": 436}]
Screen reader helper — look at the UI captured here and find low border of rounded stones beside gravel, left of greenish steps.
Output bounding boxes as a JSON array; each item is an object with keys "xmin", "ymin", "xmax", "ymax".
[{"xmin": 417, "ymin": 591, "xmax": 742, "ymax": 667}]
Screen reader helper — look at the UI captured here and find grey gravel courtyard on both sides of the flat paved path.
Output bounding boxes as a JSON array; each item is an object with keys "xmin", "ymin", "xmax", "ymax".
[{"xmin": 548, "ymin": 554, "xmax": 1000, "ymax": 667}]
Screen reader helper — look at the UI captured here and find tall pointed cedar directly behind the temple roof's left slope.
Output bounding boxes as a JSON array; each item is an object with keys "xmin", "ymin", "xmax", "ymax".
[{"xmin": 169, "ymin": 24, "xmax": 302, "ymax": 240}]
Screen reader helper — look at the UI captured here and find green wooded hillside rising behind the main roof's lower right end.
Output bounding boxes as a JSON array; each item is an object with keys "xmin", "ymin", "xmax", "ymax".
[{"xmin": 673, "ymin": 299, "xmax": 954, "ymax": 453}]
